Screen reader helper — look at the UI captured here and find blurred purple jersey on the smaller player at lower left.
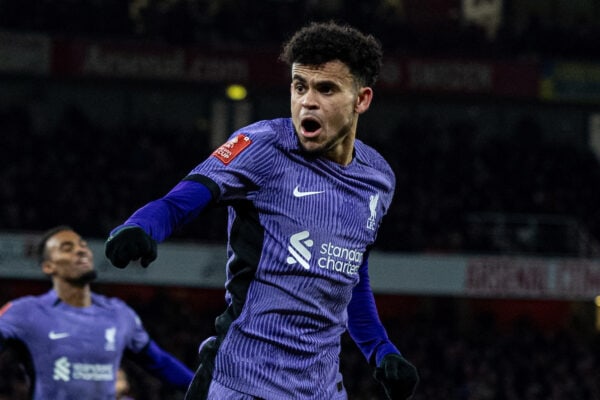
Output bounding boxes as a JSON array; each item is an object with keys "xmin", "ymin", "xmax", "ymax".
[{"xmin": 0, "ymin": 290, "xmax": 150, "ymax": 400}]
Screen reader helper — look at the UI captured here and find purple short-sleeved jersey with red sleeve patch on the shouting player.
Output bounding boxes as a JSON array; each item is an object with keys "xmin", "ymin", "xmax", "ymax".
[{"xmin": 187, "ymin": 119, "xmax": 395, "ymax": 399}]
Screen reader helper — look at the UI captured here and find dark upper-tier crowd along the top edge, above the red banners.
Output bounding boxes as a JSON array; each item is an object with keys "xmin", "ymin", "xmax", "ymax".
[{"xmin": 0, "ymin": 0, "xmax": 600, "ymax": 59}]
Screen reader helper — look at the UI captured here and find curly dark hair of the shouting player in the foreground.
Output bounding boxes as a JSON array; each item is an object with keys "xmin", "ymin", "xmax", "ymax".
[{"xmin": 279, "ymin": 21, "xmax": 383, "ymax": 86}]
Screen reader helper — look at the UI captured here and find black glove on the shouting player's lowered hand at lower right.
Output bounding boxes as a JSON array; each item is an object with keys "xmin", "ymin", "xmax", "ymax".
[{"xmin": 374, "ymin": 354, "xmax": 419, "ymax": 400}]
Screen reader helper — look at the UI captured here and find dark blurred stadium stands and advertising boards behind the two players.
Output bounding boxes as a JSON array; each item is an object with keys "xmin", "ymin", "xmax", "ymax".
[{"xmin": 0, "ymin": 0, "xmax": 600, "ymax": 400}]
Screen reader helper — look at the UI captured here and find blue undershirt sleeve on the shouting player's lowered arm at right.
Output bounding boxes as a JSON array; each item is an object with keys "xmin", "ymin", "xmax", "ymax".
[{"xmin": 348, "ymin": 257, "xmax": 400, "ymax": 365}]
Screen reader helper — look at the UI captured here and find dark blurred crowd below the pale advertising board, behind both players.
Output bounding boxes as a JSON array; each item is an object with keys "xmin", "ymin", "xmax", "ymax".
[{"xmin": 0, "ymin": 282, "xmax": 600, "ymax": 400}]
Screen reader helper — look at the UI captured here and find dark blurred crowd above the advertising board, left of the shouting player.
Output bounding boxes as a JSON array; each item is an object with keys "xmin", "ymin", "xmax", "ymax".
[{"xmin": 0, "ymin": 103, "xmax": 224, "ymax": 240}]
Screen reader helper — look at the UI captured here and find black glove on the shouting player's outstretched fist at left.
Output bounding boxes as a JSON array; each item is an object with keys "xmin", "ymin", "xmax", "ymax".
[{"xmin": 104, "ymin": 226, "xmax": 156, "ymax": 268}]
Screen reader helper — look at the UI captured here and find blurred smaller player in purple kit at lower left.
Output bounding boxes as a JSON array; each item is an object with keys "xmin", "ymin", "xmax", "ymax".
[{"xmin": 0, "ymin": 226, "xmax": 193, "ymax": 400}]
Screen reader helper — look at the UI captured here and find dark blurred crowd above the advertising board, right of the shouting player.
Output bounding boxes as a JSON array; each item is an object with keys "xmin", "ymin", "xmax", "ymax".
[{"xmin": 374, "ymin": 114, "xmax": 600, "ymax": 255}]
